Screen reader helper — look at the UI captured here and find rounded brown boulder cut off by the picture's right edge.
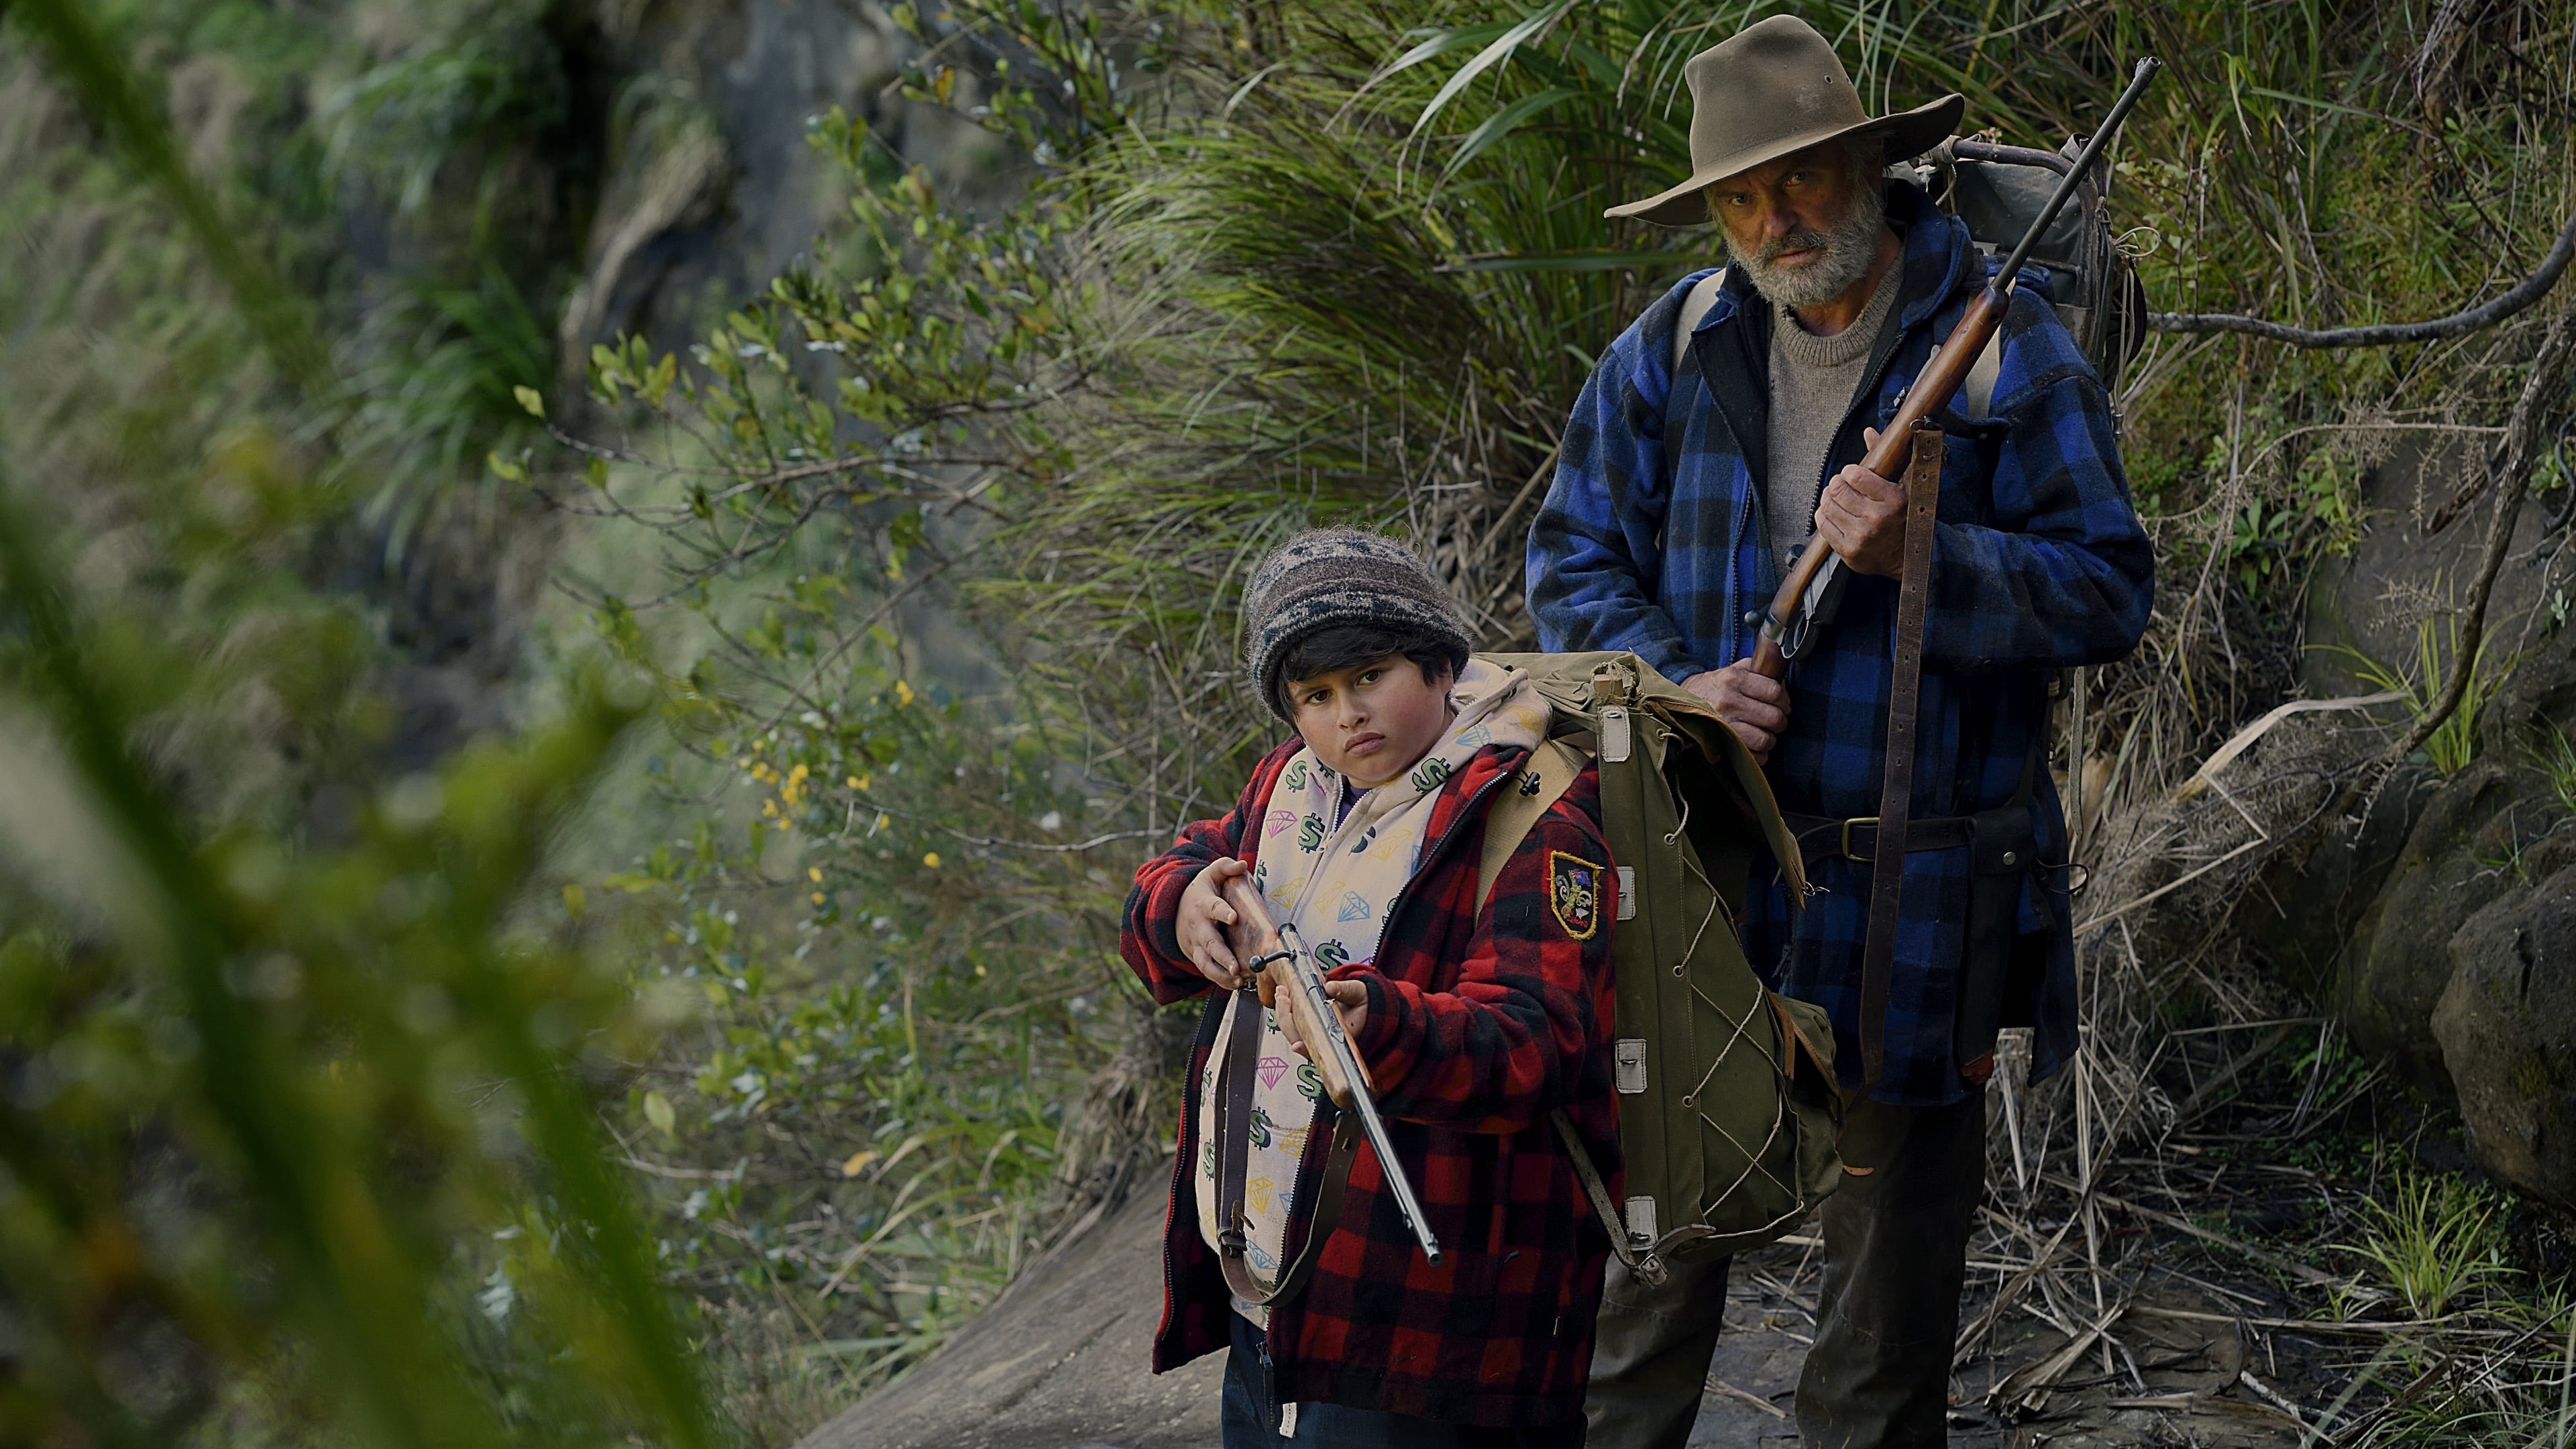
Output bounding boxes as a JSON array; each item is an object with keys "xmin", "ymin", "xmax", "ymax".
[{"xmin": 2432, "ymin": 866, "xmax": 2576, "ymax": 1207}]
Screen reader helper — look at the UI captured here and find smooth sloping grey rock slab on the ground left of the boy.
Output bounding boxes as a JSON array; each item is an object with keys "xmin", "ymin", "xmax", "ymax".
[{"xmin": 801, "ymin": 1176, "xmax": 1226, "ymax": 1449}]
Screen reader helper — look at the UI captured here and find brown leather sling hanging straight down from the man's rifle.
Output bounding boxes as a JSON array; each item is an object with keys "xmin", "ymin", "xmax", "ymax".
[{"xmin": 1860, "ymin": 423, "xmax": 1942, "ymax": 1088}]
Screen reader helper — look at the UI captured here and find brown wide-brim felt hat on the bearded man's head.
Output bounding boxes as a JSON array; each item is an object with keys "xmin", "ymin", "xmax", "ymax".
[{"xmin": 1602, "ymin": 15, "xmax": 1968, "ymax": 227}]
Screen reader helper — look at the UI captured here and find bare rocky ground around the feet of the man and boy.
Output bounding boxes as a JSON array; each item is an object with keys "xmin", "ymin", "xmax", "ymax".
[{"xmin": 804, "ymin": 1191, "xmax": 2328, "ymax": 1449}]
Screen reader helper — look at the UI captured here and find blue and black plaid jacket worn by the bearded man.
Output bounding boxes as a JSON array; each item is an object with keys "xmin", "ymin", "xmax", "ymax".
[{"xmin": 1527, "ymin": 183, "xmax": 2153, "ymax": 1106}]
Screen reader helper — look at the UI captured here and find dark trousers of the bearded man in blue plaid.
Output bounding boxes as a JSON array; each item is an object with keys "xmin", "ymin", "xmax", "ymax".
[{"xmin": 1576, "ymin": 1095, "xmax": 1986, "ymax": 1449}]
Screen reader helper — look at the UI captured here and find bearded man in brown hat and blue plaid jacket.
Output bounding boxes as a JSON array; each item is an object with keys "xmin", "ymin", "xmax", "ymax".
[{"xmin": 1527, "ymin": 15, "xmax": 2153, "ymax": 1449}]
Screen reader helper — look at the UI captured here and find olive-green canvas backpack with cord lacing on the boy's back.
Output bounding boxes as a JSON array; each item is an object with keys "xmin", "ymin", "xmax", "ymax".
[{"xmin": 1479, "ymin": 652, "xmax": 1842, "ymax": 1284}]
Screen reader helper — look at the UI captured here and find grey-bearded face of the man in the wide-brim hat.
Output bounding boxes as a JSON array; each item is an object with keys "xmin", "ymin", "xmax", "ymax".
[{"xmin": 1708, "ymin": 142, "xmax": 1886, "ymax": 307}]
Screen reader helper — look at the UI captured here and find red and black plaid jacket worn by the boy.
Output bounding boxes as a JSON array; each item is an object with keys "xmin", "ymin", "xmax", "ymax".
[{"xmin": 1118, "ymin": 740, "xmax": 1620, "ymax": 1426}]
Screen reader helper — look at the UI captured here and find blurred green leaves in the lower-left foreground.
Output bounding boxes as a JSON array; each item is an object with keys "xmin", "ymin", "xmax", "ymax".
[{"xmin": 0, "ymin": 433, "xmax": 714, "ymax": 1444}]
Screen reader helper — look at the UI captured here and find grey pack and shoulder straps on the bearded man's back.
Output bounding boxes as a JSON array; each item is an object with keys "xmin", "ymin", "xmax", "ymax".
[{"xmin": 1672, "ymin": 137, "xmax": 2146, "ymax": 420}]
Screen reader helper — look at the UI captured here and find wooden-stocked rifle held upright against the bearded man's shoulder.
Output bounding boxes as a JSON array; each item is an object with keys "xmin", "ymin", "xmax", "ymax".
[{"xmin": 1754, "ymin": 57, "xmax": 2164, "ymax": 678}]
